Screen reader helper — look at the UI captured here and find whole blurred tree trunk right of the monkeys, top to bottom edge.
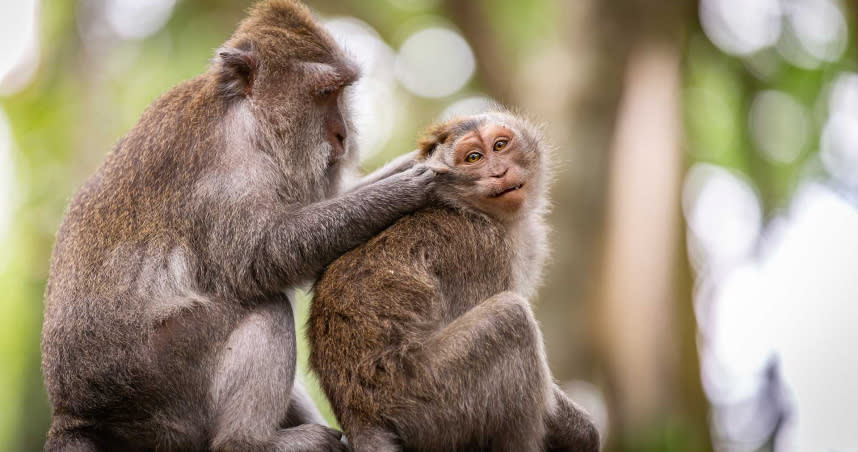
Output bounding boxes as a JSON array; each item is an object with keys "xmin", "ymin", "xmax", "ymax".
[{"xmin": 596, "ymin": 0, "xmax": 711, "ymax": 450}]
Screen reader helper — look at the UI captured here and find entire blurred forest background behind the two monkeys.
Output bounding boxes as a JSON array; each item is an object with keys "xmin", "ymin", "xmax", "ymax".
[{"xmin": 0, "ymin": 0, "xmax": 858, "ymax": 452}]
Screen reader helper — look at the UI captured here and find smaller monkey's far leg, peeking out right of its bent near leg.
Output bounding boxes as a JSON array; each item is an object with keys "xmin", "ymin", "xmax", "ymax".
[{"xmin": 545, "ymin": 385, "xmax": 599, "ymax": 452}]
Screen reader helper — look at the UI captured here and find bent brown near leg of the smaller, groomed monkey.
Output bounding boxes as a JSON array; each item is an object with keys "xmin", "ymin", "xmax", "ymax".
[{"xmin": 386, "ymin": 292, "xmax": 550, "ymax": 452}]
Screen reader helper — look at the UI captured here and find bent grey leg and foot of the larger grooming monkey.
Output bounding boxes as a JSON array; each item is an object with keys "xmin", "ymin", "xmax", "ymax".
[{"xmin": 211, "ymin": 303, "xmax": 346, "ymax": 452}]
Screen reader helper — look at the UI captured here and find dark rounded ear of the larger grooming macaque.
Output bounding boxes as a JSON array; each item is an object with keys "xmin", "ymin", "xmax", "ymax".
[{"xmin": 214, "ymin": 41, "xmax": 259, "ymax": 98}]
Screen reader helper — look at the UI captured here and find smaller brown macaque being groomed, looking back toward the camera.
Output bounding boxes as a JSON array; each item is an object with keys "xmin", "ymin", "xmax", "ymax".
[{"xmin": 309, "ymin": 112, "xmax": 599, "ymax": 452}]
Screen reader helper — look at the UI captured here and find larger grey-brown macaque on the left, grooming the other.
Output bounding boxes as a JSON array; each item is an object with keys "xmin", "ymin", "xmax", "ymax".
[{"xmin": 42, "ymin": 0, "xmax": 434, "ymax": 452}]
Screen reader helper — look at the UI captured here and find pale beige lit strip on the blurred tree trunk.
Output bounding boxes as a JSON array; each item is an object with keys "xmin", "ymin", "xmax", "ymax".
[{"xmin": 598, "ymin": 41, "xmax": 681, "ymax": 430}]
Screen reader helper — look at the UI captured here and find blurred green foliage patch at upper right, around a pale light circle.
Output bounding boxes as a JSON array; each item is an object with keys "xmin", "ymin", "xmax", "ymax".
[{"xmin": 682, "ymin": 9, "xmax": 856, "ymax": 212}]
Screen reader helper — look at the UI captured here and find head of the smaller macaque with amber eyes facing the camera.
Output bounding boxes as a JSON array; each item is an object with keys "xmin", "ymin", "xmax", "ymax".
[{"xmin": 419, "ymin": 112, "xmax": 546, "ymax": 220}]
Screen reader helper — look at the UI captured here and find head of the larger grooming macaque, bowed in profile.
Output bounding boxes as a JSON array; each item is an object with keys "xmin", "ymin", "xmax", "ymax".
[{"xmin": 212, "ymin": 0, "xmax": 359, "ymax": 201}]
